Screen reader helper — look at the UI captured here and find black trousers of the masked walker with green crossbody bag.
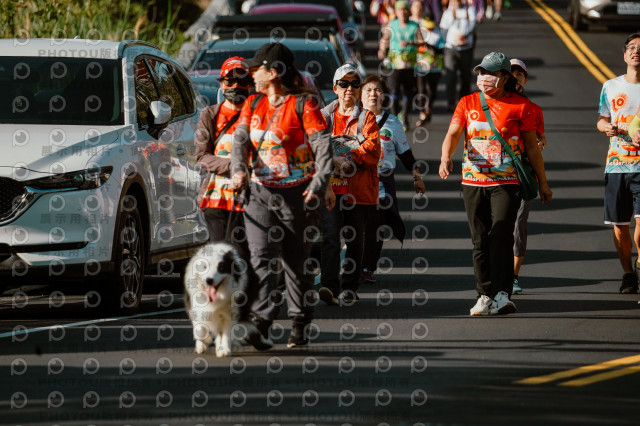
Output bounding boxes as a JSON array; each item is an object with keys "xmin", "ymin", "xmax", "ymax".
[{"xmin": 462, "ymin": 185, "xmax": 520, "ymax": 298}]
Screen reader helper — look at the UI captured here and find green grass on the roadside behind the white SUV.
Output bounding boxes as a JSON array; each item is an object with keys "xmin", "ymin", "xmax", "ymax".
[{"xmin": 0, "ymin": 0, "xmax": 200, "ymax": 56}]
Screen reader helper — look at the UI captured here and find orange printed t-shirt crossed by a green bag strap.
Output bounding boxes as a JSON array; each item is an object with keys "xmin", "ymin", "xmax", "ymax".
[{"xmin": 451, "ymin": 92, "xmax": 535, "ymax": 186}]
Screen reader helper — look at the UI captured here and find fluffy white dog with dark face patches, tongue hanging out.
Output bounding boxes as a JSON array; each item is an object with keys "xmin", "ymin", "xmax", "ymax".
[{"xmin": 184, "ymin": 242, "xmax": 247, "ymax": 357}]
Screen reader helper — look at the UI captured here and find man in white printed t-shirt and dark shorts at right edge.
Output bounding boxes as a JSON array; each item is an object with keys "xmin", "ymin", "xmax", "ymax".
[{"xmin": 597, "ymin": 33, "xmax": 640, "ymax": 294}]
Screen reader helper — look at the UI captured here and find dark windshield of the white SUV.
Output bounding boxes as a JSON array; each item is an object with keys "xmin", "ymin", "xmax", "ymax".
[{"xmin": 0, "ymin": 56, "xmax": 124, "ymax": 126}]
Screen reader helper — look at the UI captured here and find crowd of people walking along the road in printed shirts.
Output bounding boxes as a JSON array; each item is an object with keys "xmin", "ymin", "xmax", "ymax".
[{"xmin": 197, "ymin": 0, "xmax": 640, "ymax": 350}]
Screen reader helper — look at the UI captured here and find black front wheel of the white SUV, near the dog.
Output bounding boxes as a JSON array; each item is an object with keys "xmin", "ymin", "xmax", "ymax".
[{"xmin": 98, "ymin": 195, "xmax": 146, "ymax": 314}]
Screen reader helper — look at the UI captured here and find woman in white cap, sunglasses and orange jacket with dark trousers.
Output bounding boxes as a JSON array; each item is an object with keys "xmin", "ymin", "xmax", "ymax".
[{"xmin": 318, "ymin": 64, "xmax": 381, "ymax": 306}]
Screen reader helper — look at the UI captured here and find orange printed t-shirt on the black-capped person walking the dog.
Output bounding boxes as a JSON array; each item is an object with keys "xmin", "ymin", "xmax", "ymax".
[{"xmin": 239, "ymin": 95, "xmax": 327, "ymax": 187}]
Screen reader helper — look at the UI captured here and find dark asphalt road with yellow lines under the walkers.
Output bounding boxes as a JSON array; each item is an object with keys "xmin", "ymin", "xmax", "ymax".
[{"xmin": 0, "ymin": 1, "xmax": 640, "ymax": 425}]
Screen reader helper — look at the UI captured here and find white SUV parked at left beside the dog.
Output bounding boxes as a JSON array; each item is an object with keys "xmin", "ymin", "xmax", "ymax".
[{"xmin": 0, "ymin": 39, "xmax": 207, "ymax": 312}]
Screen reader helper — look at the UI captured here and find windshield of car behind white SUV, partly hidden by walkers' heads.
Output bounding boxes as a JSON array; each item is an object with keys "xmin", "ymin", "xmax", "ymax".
[{"xmin": 193, "ymin": 49, "xmax": 339, "ymax": 90}]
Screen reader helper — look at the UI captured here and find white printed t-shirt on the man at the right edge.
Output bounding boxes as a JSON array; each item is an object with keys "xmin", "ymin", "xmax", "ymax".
[{"xmin": 598, "ymin": 76, "xmax": 640, "ymax": 173}]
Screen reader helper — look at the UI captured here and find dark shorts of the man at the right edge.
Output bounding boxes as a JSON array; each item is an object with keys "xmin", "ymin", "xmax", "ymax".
[{"xmin": 604, "ymin": 173, "xmax": 640, "ymax": 225}]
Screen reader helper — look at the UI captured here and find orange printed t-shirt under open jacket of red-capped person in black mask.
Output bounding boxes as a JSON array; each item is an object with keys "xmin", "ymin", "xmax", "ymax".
[{"xmin": 200, "ymin": 104, "xmax": 241, "ymax": 210}]
